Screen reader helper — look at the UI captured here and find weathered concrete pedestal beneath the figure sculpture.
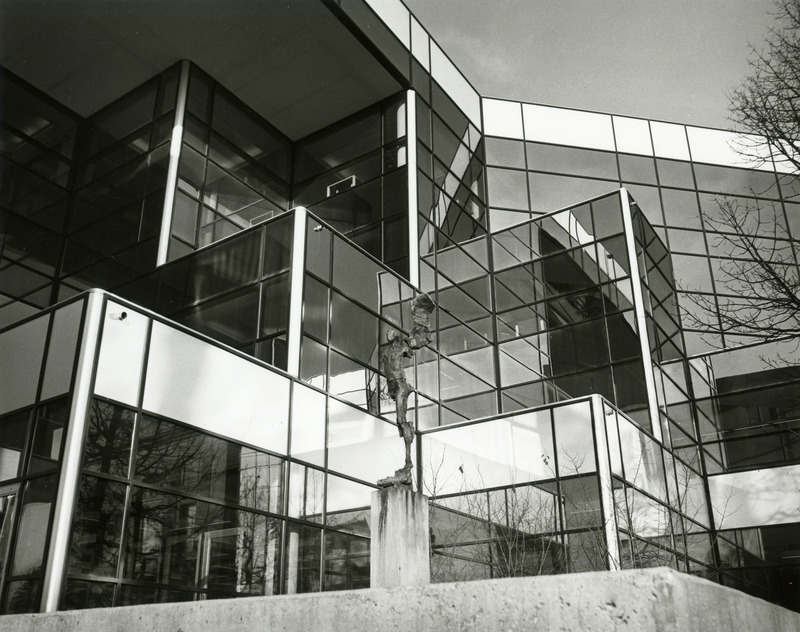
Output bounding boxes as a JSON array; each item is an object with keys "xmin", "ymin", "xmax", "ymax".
[{"xmin": 370, "ymin": 487, "xmax": 431, "ymax": 588}]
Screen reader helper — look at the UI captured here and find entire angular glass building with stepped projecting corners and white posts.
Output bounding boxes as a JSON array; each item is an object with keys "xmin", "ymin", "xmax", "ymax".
[{"xmin": 0, "ymin": 0, "xmax": 800, "ymax": 613}]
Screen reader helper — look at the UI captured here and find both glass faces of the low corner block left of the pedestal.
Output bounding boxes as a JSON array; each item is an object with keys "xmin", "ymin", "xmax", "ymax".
[{"xmin": 0, "ymin": 297, "xmax": 378, "ymax": 613}]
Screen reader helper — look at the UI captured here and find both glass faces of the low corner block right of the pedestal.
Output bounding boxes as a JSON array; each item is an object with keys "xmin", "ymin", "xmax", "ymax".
[{"xmin": 421, "ymin": 399, "xmax": 716, "ymax": 581}]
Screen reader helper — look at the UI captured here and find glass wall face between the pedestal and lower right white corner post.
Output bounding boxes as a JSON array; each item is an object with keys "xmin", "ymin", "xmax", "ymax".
[{"xmin": 420, "ymin": 399, "xmax": 614, "ymax": 582}]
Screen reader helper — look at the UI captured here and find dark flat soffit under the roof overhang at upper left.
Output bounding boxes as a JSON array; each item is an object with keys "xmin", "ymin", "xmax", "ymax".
[{"xmin": 0, "ymin": 0, "xmax": 401, "ymax": 139}]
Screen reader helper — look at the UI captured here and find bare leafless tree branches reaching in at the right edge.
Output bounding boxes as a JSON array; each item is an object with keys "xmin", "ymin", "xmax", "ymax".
[{"xmin": 682, "ymin": 0, "xmax": 800, "ymax": 356}]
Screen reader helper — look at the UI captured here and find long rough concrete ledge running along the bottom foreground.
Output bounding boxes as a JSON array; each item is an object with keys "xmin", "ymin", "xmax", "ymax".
[{"xmin": 0, "ymin": 568, "xmax": 800, "ymax": 632}]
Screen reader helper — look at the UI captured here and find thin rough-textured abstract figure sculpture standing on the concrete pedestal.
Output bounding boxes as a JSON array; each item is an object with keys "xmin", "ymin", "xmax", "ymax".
[{"xmin": 378, "ymin": 294, "xmax": 436, "ymax": 487}]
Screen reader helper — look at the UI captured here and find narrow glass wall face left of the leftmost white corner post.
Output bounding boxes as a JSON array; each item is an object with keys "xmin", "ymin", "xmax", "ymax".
[{"xmin": 0, "ymin": 301, "xmax": 84, "ymax": 614}]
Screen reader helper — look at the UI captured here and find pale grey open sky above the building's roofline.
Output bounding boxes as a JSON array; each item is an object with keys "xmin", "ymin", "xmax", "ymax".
[{"xmin": 404, "ymin": 0, "xmax": 775, "ymax": 128}]
